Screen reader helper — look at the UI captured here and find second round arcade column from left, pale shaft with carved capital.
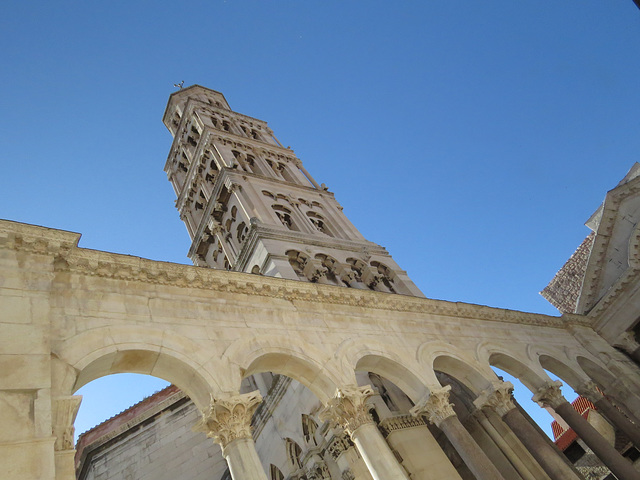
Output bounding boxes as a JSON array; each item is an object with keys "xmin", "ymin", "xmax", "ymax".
[{"xmin": 320, "ymin": 385, "xmax": 409, "ymax": 480}]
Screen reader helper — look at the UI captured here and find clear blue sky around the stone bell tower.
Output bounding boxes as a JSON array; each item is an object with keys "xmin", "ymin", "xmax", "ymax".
[{"xmin": 0, "ymin": 0, "xmax": 640, "ymax": 442}]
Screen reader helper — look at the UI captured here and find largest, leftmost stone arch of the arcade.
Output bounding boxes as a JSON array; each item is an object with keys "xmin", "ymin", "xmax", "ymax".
[{"xmin": 56, "ymin": 327, "xmax": 222, "ymax": 410}]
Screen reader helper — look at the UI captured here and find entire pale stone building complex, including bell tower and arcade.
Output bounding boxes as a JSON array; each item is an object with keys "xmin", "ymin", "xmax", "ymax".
[{"xmin": 0, "ymin": 86, "xmax": 640, "ymax": 480}]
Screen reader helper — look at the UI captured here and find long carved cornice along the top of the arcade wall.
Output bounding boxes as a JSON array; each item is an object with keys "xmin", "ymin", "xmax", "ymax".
[{"xmin": 0, "ymin": 221, "xmax": 594, "ymax": 329}]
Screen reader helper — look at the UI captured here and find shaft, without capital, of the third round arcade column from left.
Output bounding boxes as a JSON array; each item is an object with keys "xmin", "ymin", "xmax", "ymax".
[{"xmin": 438, "ymin": 415, "xmax": 504, "ymax": 480}]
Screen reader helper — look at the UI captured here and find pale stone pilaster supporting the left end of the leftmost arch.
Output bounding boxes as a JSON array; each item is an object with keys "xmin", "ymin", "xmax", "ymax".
[{"xmin": 51, "ymin": 395, "xmax": 82, "ymax": 480}]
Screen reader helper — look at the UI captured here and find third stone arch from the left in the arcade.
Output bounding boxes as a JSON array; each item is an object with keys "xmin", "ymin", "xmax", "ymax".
[{"xmin": 339, "ymin": 339, "xmax": 430, "ymax": 403}]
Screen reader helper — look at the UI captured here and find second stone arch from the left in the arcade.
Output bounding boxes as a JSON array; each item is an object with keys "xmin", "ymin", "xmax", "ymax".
[{"xmin": 223, "ymin": 335, "xmax": 343, "ymax": 403}]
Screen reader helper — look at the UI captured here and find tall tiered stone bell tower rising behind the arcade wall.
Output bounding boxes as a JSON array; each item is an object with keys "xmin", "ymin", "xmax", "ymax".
[{"xmin": 163, "ymin": 85, "xmax": 423, "ymax": 297}]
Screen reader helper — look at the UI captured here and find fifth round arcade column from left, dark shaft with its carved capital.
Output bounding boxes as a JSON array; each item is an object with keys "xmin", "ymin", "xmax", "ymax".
[{"xmin": 533, "ymin": 380, "xmax": 640, "ymax": 480}]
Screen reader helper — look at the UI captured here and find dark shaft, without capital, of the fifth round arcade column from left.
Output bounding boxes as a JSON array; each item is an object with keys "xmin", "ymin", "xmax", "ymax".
[{"xmin": 554, "ymin": 400, "xmax": 640, "ymax": 480}]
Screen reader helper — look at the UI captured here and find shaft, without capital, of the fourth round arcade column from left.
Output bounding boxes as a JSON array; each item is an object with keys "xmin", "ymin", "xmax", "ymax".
[{"xmin": 502, "ymin": 408, "xmax": 582, "ymax": 480}]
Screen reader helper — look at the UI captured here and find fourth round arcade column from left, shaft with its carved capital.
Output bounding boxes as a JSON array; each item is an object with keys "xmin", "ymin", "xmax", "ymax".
[{"xmin": 473, "ymin": 382, "xmax": 581, "ymax": 480}]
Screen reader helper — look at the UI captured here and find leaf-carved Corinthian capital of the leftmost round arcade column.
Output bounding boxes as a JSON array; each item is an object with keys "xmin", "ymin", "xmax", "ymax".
[{"xmin": 193, "ymin": 390, "xmax": 262, "ymax": 450}]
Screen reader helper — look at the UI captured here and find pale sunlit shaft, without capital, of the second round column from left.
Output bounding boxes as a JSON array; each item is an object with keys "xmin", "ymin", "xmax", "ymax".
[{"xmin": 351, "ymin": 423, "xmax": 409, "ymax": 480}]
